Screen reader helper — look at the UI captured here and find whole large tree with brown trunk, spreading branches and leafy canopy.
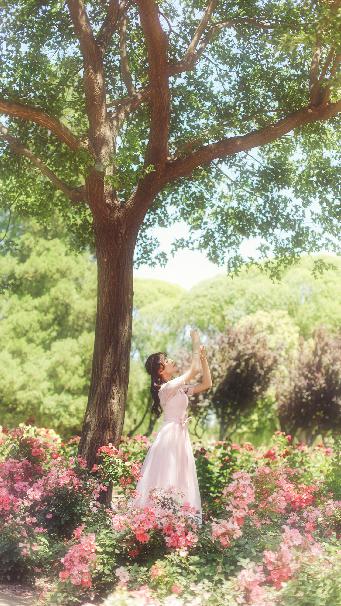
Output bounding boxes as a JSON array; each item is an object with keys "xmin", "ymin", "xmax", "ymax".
[{"xmin": 0, "ymin": 0, "xmax": 341, "ymax": 466}]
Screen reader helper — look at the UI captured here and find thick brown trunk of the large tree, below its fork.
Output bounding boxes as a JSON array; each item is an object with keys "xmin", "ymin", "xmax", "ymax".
[{"xmin": 78, "ymin": 219, "xmax": 136, "ymax": 478}]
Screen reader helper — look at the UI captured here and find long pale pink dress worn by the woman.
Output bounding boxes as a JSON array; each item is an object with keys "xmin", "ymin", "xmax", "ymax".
[{"xmin": 128, "ymin": 375, "xmax": 202, "ymax": 525}]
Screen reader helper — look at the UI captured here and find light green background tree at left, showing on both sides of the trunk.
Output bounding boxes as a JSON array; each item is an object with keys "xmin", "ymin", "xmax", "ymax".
[{"xmin": 0, "ymin": 221, "xmax": 181, "ymax": 438}]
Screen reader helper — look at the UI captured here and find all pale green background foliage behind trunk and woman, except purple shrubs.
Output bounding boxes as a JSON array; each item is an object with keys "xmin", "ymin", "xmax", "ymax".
[{"xmin": 0, "ymin": 221, "xmax": 341, "ymax": 443}]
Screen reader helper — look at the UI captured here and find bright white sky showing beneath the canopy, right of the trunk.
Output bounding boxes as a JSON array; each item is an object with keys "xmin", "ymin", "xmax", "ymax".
[{"xmin": 134, "ymin": 222, "xmax": 256, "ymax": 289}]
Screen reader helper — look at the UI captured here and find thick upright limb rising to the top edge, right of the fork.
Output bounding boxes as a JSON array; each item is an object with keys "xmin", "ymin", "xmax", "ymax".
[{"xmin": 137, "ymin": 0, "xmax": 170, "ymax": 171}]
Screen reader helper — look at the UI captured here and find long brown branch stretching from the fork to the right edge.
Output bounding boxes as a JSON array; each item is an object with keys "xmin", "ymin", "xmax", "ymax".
[{"xmin": 164, "ymin": 100, "xmax": 341, "ymax": 184}]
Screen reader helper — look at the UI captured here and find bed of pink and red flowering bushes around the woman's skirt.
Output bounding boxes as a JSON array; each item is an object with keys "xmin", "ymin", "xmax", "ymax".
[{"xmin": 0, "ymin": 424, "xmax": 341, "ymax": 606}]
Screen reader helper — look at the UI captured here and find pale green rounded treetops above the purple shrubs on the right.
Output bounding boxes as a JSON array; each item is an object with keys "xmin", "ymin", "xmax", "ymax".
[{"xmin": 169, "ymin": 256, "xmax": 341, "ymax": 338}]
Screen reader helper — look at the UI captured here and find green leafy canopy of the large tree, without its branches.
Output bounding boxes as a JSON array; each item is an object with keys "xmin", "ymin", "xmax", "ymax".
[{"xmin": 0, "ymin": 0, "xmax": 340, "ymax": 269}]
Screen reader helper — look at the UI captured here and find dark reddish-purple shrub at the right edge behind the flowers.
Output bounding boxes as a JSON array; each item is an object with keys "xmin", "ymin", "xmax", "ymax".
[{"xmin": 278, "ymin": 329, "xmax": 341, "ymax": 444}]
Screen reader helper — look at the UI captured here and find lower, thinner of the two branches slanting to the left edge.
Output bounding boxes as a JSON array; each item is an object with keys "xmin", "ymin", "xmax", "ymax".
[{"xmin": 0, "ymin": 124, "xmax": 85, "ymax": 203}]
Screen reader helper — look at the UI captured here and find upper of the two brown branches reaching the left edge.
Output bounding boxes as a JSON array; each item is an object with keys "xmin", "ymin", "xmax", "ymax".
[{"xmin": 0, "ymin": 99, "xmax": 82, "ymax": 151}]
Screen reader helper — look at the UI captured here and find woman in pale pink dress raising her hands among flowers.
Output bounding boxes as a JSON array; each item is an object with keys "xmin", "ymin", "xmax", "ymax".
[{"xmin": 129, "ymin": 330, "xmax": 212, "ymax": 524}]
